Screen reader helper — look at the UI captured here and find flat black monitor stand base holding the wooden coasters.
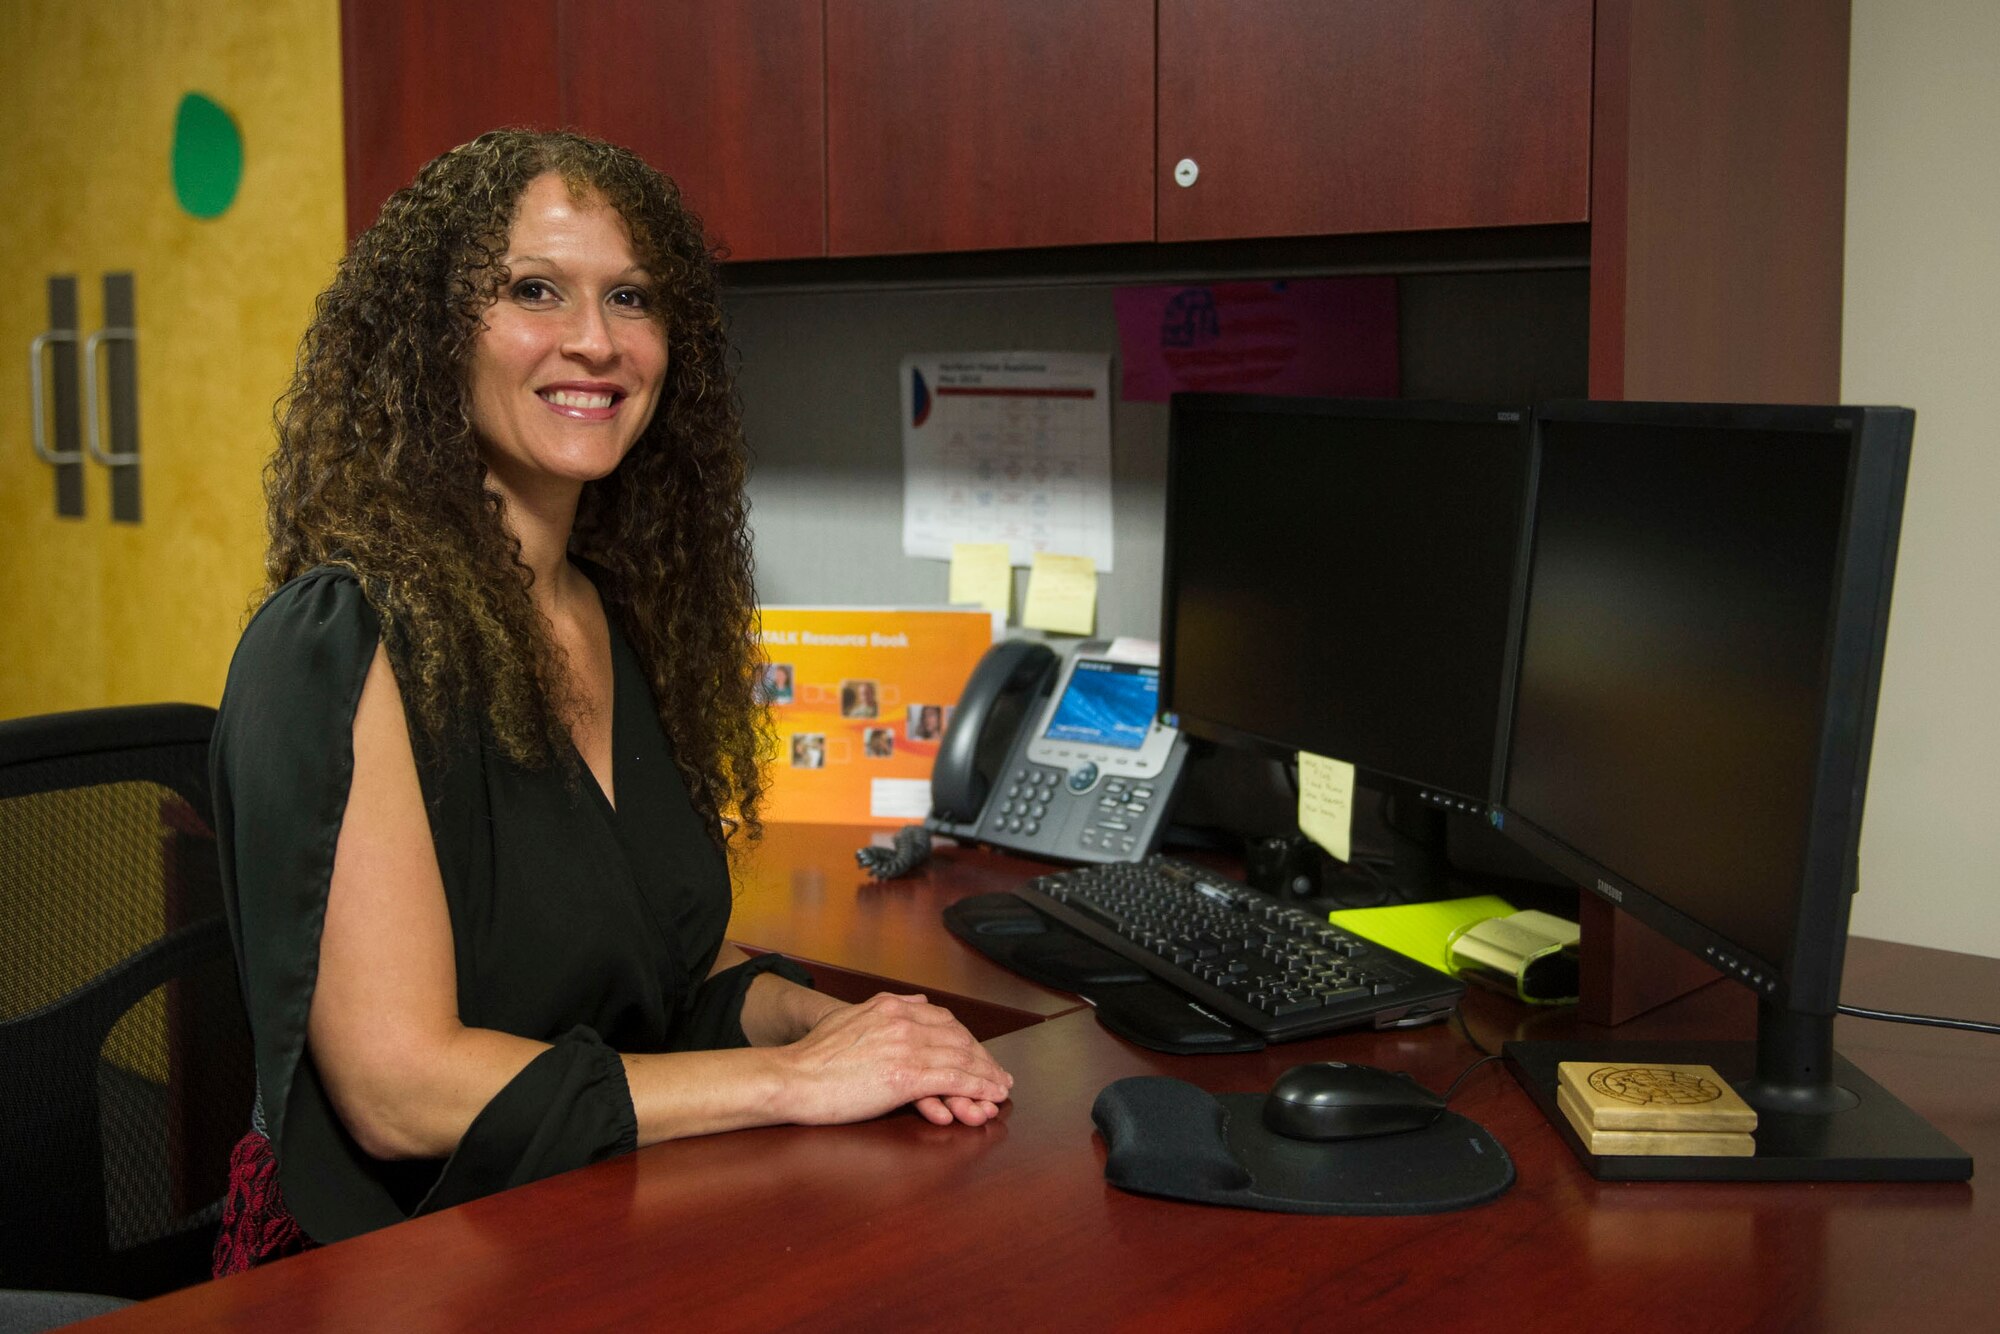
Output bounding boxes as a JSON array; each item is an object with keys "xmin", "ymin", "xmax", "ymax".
[{"xmin": 1502, "ymin": 1004, "xmax": 1972, "ymax": 1182}]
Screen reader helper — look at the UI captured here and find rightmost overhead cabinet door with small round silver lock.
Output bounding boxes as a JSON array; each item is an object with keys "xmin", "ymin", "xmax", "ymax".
[{"xmin": 1158, "ymin": 0, "xmax": 1590, "ymax": 240}]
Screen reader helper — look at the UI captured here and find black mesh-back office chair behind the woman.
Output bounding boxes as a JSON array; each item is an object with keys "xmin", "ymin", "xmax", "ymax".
[{"xmin": 0, "ymin": 704, "xmax": 254, "ymax": 1298}]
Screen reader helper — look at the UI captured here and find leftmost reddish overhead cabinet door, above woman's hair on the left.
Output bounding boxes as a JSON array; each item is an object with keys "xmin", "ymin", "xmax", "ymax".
[{"xmin": 340, "ymin": 0, "xmax": 560, "ymax": 238}]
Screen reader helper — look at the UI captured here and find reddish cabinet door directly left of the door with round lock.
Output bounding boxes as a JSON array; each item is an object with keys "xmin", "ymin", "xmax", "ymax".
[{"xmin": 826, "ymin": 0, "xmax": 1154, "ymax": 254}]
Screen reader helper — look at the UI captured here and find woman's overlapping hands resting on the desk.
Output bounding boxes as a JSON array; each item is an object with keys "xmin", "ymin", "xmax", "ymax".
[{"xmin": 778, "ymin": 992, "xmax": 1014, "ymax": 1126}]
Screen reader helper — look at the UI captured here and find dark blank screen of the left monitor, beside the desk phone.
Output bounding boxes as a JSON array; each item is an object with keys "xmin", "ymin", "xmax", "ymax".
[{"xmin": 1160, "ymin": 394, "xmax": 1528, "ymax": 802}]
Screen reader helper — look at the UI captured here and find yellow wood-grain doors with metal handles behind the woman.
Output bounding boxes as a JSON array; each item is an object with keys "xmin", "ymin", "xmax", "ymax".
[{"xmin": 0, "ymin": 0, "xmax": 344, "ymax": 718}]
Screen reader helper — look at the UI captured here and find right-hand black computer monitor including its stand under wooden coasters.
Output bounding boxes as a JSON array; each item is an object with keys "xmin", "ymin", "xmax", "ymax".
[{"xmin": 1492, "ymin": 404, "xmax": 1970, "ymax": 1178}]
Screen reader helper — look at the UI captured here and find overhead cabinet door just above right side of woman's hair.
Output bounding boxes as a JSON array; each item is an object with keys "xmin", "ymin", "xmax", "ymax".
[{"xmin": 560, "ymin": 0, "xmax": 826, "ymax": 260}]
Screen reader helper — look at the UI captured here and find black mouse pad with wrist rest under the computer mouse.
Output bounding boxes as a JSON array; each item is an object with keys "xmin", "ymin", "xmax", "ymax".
[{"xmin": 1090, "ymin": 1074, "xmax": 1514, "ymax": 1214}]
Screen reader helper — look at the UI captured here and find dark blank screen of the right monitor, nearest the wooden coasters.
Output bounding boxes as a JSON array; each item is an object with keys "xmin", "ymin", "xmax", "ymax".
[{"xmin": 1502, "ymin": 420, "xmax": 1850, "ymax": 966}]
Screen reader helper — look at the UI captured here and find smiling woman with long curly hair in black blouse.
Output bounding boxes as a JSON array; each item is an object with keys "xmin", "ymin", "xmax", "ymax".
[{"xmin": 212, "ymin": 130, "xmax": 1012, "ymax": 1272}]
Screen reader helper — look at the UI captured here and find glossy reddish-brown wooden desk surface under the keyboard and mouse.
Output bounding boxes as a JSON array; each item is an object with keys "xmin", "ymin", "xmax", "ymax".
[{"xmin": 94, "ymin": 830, "xmax": 2000, "ymax": 1332}]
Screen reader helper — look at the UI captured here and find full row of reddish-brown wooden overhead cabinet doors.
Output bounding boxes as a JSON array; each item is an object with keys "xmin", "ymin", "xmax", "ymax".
[{"xmin": 342, "ymin": 0, "xmax": 1592, "ymax": 260}]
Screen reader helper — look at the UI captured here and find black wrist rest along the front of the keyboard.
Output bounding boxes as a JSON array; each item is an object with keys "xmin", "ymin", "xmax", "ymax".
[{"xmin": 944, "ymin": 894, "xmax": 1264, "ymax": 1056}]
